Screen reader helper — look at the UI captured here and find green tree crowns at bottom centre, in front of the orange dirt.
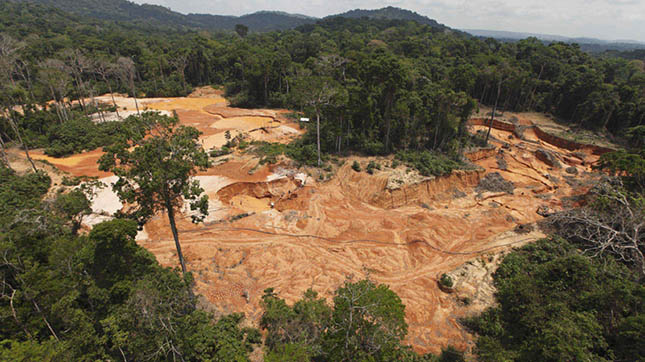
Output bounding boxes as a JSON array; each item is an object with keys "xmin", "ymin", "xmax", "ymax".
[{"xmin": 260, "ymin": 279, "xmax": 426, "ymax": 361}]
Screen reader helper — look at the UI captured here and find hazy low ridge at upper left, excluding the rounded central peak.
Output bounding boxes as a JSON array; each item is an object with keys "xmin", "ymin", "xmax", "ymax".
[{"xmin": 12, "ymin": 0, "xmax": 317, "ymax": 31}]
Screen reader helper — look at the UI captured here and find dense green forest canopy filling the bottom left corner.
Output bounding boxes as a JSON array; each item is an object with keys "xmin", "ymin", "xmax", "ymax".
[{"xmin": 0, "ymin": 169, "xmax": 260, "ymax": 361}]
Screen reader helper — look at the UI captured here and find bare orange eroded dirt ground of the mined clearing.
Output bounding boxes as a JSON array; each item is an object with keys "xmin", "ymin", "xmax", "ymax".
[{"xmin": 12, "ymin": 89, "xmax": 598, "ymax": 353}]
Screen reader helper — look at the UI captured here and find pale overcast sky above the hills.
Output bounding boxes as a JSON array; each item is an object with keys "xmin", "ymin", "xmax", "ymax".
[{"xmin": 133, "ymin": 0, "xmax": 645, "ymax": 41}]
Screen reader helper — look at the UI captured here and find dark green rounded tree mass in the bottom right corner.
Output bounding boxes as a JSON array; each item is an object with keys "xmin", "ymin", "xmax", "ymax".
[{"xmin": 466, "ymin": 239, "xmax": 645, "ymax": 361}]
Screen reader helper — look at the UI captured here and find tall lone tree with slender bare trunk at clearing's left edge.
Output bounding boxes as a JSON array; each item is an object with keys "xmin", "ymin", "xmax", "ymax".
[{"xmin": 99, "ymin": 112, "xmax": 210, "ymax": 273}]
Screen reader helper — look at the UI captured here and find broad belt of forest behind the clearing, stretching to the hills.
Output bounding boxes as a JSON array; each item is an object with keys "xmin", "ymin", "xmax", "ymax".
[{"xmin": 0, "ymin": 2, "xmax": 645, "ymax": 165}]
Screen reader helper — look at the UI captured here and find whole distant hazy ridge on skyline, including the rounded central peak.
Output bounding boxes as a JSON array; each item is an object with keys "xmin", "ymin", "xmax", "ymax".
[{"xmin": 7, "ymin": 0, "xmax": 453, "ymax": 32}]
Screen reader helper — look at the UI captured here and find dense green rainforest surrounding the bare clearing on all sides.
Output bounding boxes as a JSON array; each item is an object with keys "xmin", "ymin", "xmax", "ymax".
[{"xmin": 0, "ymin": 2, "xmax": 645, "ymax": 361}]
